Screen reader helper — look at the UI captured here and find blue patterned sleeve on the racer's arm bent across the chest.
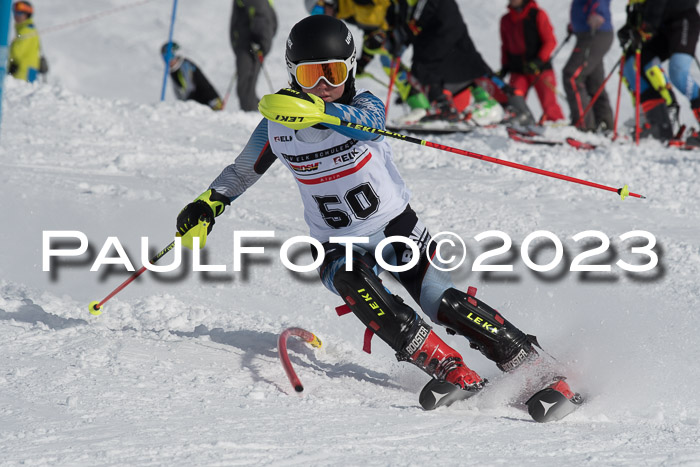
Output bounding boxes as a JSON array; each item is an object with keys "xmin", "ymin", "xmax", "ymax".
[{"xmin": 325, "ymin": 91, "xmax": 386, "ymax": 141}]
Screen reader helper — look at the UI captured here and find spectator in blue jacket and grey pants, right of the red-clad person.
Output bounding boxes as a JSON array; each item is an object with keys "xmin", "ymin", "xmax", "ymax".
[{"xmin": 562, "ymin": 0, "xmax": 614, "ymax": 131}]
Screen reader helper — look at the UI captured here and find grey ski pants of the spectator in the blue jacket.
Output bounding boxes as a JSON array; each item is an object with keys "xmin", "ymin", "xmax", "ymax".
[{"xmin": 562, "ymin": 31, "xmax": 614, "ymax": 130}]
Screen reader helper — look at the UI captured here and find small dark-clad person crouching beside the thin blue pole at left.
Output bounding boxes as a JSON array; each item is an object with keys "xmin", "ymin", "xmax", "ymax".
[{"xmin": 160, "ymin": 42, "xmax": 222, "ymax": 110}]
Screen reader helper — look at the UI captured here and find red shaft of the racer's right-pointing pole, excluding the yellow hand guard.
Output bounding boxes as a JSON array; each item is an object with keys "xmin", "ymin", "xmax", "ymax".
[{"xmin": 334, "ymin": 116, "xmax": 646, "ymax": 200}]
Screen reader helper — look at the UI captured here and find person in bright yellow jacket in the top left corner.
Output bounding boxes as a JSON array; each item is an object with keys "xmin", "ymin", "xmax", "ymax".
[{"xmin": 8, "ymin": 1, "xmax": 41, "ymax": 83}]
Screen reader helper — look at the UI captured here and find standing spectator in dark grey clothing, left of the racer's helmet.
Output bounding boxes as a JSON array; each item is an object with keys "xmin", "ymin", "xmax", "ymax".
[{"xmin": 230, "ymin": 0, "xmax": 277, "ymax": 111}]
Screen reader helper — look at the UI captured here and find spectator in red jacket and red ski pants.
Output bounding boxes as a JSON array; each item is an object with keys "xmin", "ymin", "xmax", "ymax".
[{"xmin": 501, "ymin": 0, "xmax": 564, "ymax": 121}]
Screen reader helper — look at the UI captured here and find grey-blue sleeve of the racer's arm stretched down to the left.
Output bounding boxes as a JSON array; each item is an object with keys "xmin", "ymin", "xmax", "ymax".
[{"xmin": 209, "ymin": 119, "xmax": 277, "ymax": 201}]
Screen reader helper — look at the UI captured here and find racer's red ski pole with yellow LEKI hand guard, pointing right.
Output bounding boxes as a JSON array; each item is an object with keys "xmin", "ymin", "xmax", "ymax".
[{"xmin": 258, "ymin": 89, "xmax": 645, "ymax": 200}]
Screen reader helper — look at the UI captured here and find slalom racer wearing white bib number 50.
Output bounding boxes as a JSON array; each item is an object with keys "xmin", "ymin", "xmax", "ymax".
[{"xmin": 176, "ymin": 15, "xmax": 537, "ymax": 400}]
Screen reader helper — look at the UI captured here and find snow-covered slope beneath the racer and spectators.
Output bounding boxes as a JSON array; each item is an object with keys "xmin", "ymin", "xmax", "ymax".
[{"xmin": 0, "ymin": 0, "xmax": 700, "ymax": 466}]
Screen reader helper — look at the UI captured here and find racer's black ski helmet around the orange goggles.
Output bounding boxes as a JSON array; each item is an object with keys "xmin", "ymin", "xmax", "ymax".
[{"xmin": 285, "ymin": 15, "xmax": 356, "ymax": 104}]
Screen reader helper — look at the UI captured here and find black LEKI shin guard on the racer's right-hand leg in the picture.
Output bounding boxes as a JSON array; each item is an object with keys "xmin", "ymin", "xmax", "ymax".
[{"xmin": 437, "ymin": 287, "xmax": 538, "ymax": 371}]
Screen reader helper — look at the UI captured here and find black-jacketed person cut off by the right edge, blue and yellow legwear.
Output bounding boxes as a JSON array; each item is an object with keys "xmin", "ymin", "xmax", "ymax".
[{"xmin": 617, "ymin": 0, "xmax": 700, "ymax": 146}]
